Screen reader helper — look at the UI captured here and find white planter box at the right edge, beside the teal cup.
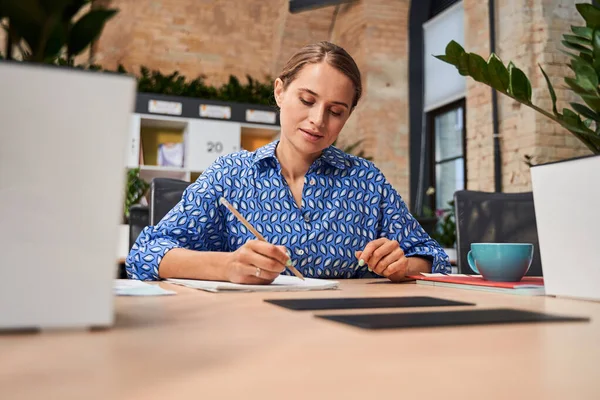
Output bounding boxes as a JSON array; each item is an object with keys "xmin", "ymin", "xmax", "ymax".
[{"xmin": 531, "ymin": 156, "xmax": 600, "ymax": 300}]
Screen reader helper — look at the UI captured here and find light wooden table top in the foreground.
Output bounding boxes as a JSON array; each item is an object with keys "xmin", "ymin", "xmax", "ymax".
[{"xmin": 0, "ymin": 280, "xmax": 600, "ymax": 400}]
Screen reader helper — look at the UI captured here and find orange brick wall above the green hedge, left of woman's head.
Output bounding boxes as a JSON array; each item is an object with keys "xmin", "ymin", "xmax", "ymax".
[{"xmin": 95, "ymin": 0, "xmax": 287, "ymax": 84}]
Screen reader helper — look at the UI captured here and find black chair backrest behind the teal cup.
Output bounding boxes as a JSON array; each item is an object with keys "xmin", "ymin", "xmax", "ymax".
[{"xmin": 454, "ymin": 190, "xmax": 542, "ymax": 276}]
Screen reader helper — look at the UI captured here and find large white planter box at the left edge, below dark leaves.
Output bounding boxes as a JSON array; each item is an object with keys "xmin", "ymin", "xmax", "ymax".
[{"xmin": 0, "ymin": 61, "xmax": 135, "ymax": 330}]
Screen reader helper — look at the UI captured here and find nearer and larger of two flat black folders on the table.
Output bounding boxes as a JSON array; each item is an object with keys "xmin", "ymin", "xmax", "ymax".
[{"xmin": 317, "ymin": 308, "xmax": 589, "ymax": 329}]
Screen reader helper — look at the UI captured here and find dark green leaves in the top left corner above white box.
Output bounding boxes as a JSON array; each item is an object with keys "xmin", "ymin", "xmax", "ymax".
[{"xmin": 0, "ymin": 0, "xmax": 117, "ymax": 65}]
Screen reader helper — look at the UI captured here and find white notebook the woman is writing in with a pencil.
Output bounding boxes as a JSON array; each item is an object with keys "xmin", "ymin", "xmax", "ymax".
[{"xmin": 167, "ymin": 275, "xmax": 339, "ymax": 292}]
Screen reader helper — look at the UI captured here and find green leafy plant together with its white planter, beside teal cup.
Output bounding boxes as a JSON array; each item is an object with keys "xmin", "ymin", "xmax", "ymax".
[{"xmin": 436, "ymin": 3, "xmax": 600, "ymax": 299}]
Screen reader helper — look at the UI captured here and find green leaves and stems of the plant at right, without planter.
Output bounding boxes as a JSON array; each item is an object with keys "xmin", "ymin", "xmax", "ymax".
[{"xmin": 436, "ymin": 3, "xmax": 600, "ymax": 154}]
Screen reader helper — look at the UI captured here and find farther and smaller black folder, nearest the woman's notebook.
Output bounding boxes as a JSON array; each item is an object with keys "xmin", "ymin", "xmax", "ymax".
[{"xmin": 265, "ymin": 296, "xmax": 475, "ymax": 311}]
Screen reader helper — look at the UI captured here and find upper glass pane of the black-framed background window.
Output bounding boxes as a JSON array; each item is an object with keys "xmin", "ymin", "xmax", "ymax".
[{"xmin": 434, "ymin": 107, "xmax": 464, "ymax": 161}]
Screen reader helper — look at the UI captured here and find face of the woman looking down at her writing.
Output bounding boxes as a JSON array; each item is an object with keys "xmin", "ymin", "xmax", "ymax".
[{"xmin": 275, "ymin": 62, "xmax": 355, "ymax": 155}]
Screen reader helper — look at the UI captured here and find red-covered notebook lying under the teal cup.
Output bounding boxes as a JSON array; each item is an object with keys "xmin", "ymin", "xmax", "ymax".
[{"xmin": 409, "ymin": 273, "xmax": 545, "ymax": 296}]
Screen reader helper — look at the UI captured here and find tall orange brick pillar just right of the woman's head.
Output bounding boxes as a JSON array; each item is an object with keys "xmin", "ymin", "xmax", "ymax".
[{"xmin": 348, "ymin": 0, "xmax": 410, "ymax": 197}]
